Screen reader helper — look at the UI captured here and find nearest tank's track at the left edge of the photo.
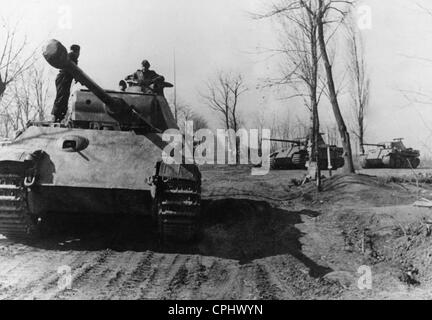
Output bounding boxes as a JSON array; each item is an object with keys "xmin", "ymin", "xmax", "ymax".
[{"xmin": 0, "ymin": 173, "xmax": 37, "ymax": 240}]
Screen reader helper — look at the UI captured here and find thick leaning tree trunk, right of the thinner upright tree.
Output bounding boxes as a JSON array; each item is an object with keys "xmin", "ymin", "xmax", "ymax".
[{"xmin": 318, "ymin": 11, "xmax": 355, "ymax": 174}]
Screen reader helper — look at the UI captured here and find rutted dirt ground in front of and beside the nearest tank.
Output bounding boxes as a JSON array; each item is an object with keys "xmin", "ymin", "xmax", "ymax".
[{"xmin": 0, "ymin": 167, "xmax": 432, "ymax": 299}]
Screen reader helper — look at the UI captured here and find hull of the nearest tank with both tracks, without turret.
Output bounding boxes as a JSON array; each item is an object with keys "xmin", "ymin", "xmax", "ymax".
[{"xmin": 0, "ymin": 125, "xmax": 201, "ymax": 240}]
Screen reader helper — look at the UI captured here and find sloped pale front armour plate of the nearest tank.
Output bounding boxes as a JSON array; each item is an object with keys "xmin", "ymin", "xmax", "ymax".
[{"xmin": 0, "ymin": 126, "xmax": 167, "ymax": 190}]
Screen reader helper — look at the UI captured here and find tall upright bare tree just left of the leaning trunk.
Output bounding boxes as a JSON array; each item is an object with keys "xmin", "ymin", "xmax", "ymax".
[{"xmin": 263, "ymin": 0, "xmax": 323, "ymax": 188}]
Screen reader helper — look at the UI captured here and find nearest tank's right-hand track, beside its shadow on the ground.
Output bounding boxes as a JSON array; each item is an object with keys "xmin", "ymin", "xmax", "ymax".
[{"xmin": 157, "ymin": 179, "xmax": 201, "ymax": 242}]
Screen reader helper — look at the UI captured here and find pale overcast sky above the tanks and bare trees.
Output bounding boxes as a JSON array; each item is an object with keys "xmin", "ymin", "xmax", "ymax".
[{"xmin": 0, "ymin": 0, "xmax": 432, "ymax": 153}]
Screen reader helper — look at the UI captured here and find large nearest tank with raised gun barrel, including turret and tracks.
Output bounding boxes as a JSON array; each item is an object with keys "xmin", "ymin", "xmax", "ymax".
[{"xmin": 0, "ymin": 40, "xmax": 201, "ymax": 241}]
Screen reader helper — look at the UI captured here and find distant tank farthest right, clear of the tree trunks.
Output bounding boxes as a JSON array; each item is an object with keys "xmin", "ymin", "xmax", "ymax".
[{"xmin": 360, "ymin": 138, "xmax": 420, "ymax": 169}]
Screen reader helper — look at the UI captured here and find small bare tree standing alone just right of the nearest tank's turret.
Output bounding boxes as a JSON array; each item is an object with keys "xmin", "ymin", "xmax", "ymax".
[{"xmin": 200, "ymin": 72, "xmax": 247, "ymax": 132}]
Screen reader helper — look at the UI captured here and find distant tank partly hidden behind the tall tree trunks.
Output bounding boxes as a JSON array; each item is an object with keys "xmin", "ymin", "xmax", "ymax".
[{"xmin": 270, "ymin": 135, "xmax": 345, "ymax": 170}]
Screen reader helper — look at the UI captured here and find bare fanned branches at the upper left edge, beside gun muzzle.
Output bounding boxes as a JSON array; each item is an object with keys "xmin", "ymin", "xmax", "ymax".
[{"xmin": 0, "ymin": 19, "xmax": 34, "ymax": 99}]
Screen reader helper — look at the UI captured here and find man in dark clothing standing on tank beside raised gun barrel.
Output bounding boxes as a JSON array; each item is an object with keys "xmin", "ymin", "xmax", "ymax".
[{"xmin": 51, "ymin": 44, "xmax": 81, "ymax": 122}]
